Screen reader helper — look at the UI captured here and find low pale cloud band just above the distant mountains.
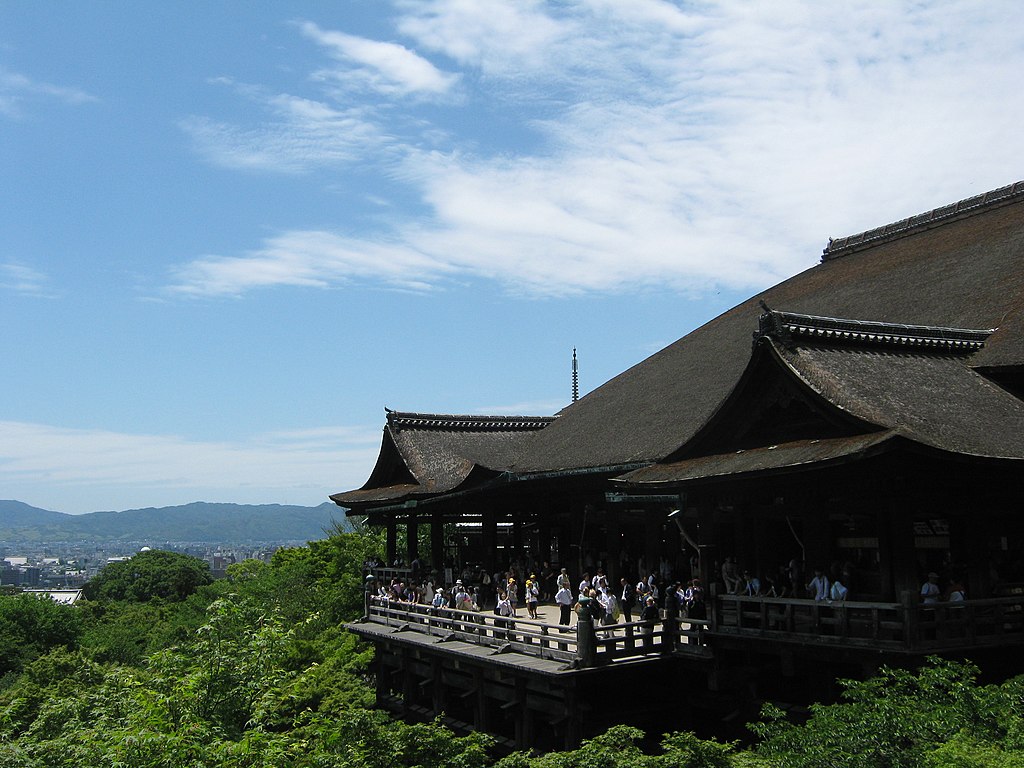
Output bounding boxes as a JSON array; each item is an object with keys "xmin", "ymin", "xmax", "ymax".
[{"xmin": 0, "ymin": 421, "xmax": 380, "ymax": 512}]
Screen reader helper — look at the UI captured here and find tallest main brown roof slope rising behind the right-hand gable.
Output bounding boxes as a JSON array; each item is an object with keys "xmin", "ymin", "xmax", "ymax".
[{"xmin": 516, "ymin": 182, "xmax": 1024, "ymax": 472}]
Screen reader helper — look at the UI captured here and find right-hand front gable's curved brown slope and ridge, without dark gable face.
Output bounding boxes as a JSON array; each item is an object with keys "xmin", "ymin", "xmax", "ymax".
[{"xmin": 757, "ymin": 311, "xmax": 1024, "ymax": 459}]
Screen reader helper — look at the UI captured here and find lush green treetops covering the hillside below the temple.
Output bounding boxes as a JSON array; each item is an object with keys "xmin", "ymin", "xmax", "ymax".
[{"xmin": 0, "ymin": 531, "xmax": 1024, "ymax": 768}]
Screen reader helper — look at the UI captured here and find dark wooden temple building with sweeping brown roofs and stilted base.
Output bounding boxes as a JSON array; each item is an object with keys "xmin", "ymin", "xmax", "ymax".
[{"xmin": 331, "ymin": 182, "xmax": 1024, "ymax": 746}]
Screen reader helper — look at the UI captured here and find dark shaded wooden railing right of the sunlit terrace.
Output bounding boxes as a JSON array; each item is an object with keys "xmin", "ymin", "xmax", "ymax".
[{"xmin": 712, "ymin": 593, "xmax": 1024, "ymax": 652}]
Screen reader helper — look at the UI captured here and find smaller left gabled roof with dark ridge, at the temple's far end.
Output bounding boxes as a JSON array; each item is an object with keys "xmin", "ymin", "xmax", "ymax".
[{"xmin": 331, "ymin": 410, "xmax": 555, "ymax": 506}]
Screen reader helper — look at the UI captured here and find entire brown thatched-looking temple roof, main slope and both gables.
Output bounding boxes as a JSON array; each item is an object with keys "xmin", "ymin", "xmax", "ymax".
[{"xmin": 332, "ymin": 182, "xmax": 1024, "ymax": 504}]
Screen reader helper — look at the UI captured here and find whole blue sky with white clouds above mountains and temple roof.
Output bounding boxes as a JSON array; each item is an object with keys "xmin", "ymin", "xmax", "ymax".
[{"xmin": 0, "ymin": 0, "xmax": 1024, "ymax": 513}]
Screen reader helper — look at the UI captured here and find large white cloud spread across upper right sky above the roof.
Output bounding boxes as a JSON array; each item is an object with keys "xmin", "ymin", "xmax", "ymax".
[{"xmin": 176, "ymin": 0, "xmax": 1024, "ymax": 295}]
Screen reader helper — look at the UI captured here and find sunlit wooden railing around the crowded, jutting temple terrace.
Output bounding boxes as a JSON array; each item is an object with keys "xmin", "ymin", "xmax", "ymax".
[{"xmin": 356, "ymin": 596, "xmax": 708, "ymax": 667}]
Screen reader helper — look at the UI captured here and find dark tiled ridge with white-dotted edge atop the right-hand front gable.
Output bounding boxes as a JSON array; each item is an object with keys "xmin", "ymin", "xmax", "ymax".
[{"xmin": 754, "ymin": 309, "xmax": 995, "ymax": 354}]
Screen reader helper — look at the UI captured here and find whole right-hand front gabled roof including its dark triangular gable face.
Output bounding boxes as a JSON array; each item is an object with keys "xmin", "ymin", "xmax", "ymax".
[{"xmin": 620, "ymin": 311, "xmax": 1024, "ymax": 485}]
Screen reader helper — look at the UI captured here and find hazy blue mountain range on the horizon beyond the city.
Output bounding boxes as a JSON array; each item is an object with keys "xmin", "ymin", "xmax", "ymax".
[{"xmin": 0, "ymin": 501, "xmax": 350, "ymax": 544}]
